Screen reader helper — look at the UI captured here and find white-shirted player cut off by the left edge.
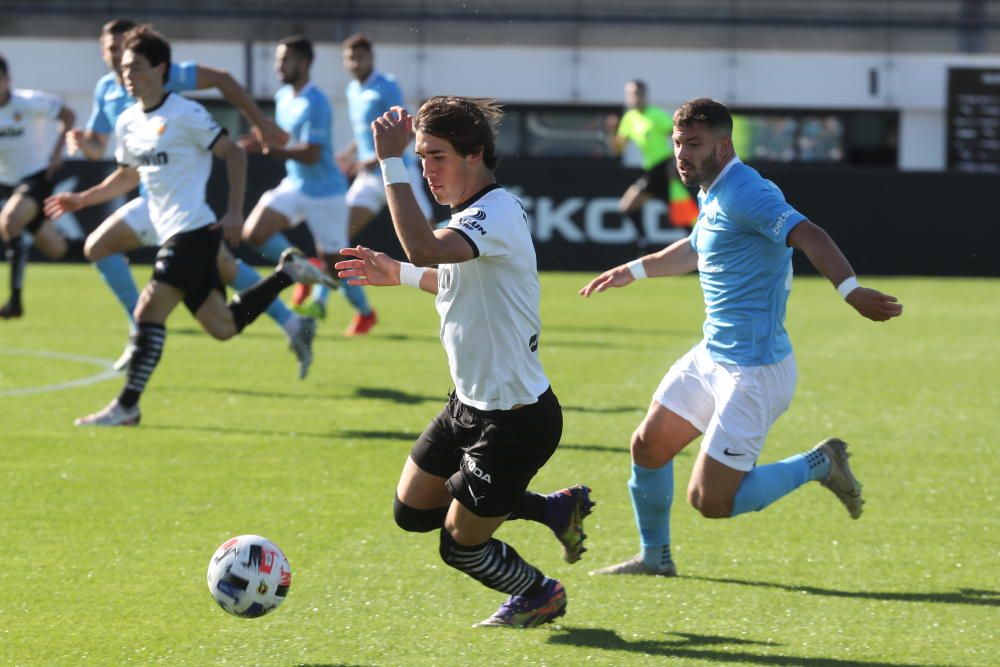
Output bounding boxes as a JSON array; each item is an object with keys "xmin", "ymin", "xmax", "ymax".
[{"xmin": 0, "ymin": 56, "xmax": 73, "ymax": 319}]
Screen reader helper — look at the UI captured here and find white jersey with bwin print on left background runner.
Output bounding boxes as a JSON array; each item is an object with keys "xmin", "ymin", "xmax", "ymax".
[{"xmin": 115, "ymin": 93, "xmax": 225, "ymax": 243}]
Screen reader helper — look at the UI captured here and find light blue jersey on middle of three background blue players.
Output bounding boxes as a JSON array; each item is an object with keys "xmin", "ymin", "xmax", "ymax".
[{"xmin": 274, "ymin": 83, "xmax": 347, "ymax": 197}]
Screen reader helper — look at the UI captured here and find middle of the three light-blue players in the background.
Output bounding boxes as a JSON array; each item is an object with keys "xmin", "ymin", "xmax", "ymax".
[{"xmin": 240, "ymin": 36, "xmax": 375, "ymax": 336}]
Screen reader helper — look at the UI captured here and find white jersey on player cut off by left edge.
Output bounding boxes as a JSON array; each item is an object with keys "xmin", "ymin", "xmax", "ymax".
[{"xmin": 0, "ymin": 89, "xmax": 63, "ymax": 186}]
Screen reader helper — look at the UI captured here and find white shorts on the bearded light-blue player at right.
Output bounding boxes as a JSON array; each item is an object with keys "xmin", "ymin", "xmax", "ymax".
[{"xmin": 653, "ymin": 341, "xmax": 798, "ymax": 471}]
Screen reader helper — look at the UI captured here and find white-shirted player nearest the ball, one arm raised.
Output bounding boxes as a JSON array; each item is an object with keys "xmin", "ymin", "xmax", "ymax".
[{"xmin": 337, "ymin": 97, "xmax": 592, "ymax": 627}]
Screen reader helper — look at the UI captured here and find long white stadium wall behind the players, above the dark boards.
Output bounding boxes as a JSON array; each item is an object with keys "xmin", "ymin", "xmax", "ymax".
[{"xmin": 0, "ymin": 38, "xmax": 1000, "ymax": 170}]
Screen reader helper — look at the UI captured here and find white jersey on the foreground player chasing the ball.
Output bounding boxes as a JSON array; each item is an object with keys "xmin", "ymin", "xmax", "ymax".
[{"xmin": 435, "ymin": 187, "xmax": 549, "ymax": 410}]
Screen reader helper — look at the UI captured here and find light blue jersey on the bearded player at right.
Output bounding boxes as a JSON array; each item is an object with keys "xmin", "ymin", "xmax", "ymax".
[{"xmin": 690, "ymin": 158, "xmax": 806, "ymax": 366}]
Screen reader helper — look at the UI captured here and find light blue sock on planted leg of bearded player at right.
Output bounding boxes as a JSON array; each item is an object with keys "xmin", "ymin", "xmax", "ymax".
[{"xmin": 628, "ymin": 461, "xmax": 674, "ymax": 570}]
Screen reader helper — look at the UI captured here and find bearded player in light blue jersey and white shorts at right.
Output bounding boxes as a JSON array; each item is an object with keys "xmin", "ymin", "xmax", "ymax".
[{"xmin": 580, "ymin": 98, "xmax": 903, "ymax": 576}]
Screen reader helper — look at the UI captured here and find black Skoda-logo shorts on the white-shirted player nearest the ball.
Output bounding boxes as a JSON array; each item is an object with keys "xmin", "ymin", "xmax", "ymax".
[{"xmin": 410, "ymin": 387, "xmax": 563, "ymax": 517}]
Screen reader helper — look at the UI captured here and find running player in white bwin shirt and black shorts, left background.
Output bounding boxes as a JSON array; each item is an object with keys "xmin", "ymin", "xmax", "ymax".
[{"xmin": 49, "ymin": 26, "xmax": 334, "ymax": 426}]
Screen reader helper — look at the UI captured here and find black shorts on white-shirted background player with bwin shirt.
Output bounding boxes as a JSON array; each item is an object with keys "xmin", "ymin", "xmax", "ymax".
[{"xmin": 153, "ymin": 226, "xmax": 226, "ymax": 315}]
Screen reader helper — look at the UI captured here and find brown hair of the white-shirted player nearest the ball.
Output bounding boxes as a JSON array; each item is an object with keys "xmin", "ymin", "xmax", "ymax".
[{"xmin": 413, "ymin": 95, "xmax": 503, "ymax": 171}]
